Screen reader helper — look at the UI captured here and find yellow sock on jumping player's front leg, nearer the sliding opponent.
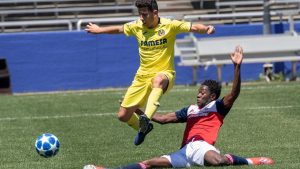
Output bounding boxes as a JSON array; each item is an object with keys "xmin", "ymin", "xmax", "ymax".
[{"xmin": 145, "ymin": 88, "xmax": 163, "ymax": 119}]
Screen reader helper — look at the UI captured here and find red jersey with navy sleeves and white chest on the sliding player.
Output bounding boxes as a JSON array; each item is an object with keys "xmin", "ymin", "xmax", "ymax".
[{"xmin": 176, "ymin": 99, "xmax": 230, "ymax": 146}]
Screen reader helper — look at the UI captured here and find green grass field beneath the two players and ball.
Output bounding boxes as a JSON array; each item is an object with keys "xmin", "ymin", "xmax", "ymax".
[{"xmin": 0, "ymin": 82, "xmax": 300, "ymax": 169}]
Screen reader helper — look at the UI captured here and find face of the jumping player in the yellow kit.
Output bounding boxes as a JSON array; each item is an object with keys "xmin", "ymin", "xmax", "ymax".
[{"xmin": 138, "ymin": 7, "xmax": 156, "ymax": 28}]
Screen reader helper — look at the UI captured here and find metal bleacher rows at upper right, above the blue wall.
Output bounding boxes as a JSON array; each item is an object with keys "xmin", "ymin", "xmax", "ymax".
[{"xmin": 189, "ymin": 0, "xmax": 300, "ymax": 24}]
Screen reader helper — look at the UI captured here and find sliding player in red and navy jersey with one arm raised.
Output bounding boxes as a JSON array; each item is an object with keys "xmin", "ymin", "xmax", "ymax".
[{"xmin": 84, "ymin": 46, "xmax": 274, "ymax": 169}]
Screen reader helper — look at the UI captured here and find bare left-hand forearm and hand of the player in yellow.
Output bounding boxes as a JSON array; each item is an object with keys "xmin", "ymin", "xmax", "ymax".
[{"xmin": 85, "ymin": 23, "xmax": 124, "ymax": 34}]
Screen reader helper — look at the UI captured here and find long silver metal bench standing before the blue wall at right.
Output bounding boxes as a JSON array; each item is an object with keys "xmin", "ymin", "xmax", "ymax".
[{"xmin": 176, "ymin": 34, "xmax": 300, "ymax": 84}]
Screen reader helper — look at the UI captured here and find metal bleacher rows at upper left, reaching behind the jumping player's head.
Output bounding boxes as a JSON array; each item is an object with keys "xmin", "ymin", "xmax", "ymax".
[{"xmin": 0, "ymin": 0, "xmax": 193, "ymax": 32}]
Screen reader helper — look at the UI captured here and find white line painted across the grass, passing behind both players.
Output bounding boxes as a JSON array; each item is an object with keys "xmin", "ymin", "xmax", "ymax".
[{"xmin": 0, "ymin": 106, "xmax": 300, "ymax": 121}]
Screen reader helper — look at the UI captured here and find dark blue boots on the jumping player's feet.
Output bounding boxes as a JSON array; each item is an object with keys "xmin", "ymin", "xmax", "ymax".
[{"xmin": 134, "ymin": 115, "xmax": 153, "ymax": 145}]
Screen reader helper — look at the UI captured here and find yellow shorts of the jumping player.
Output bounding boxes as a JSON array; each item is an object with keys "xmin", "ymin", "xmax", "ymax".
[{"xmin": 121, "ymin": 71, "xmax": 176, "ymax": 108}]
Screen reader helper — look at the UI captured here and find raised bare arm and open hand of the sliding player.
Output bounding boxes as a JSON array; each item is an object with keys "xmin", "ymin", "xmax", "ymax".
[{"xmin": 223, "ymin": 46, "xmax": 243, "ymax": 108}]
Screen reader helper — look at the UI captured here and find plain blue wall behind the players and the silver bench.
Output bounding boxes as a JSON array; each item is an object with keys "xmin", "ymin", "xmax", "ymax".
[{"xmin": 0, "ymin": 21, "xmax": 300, "ymax": 93}]
